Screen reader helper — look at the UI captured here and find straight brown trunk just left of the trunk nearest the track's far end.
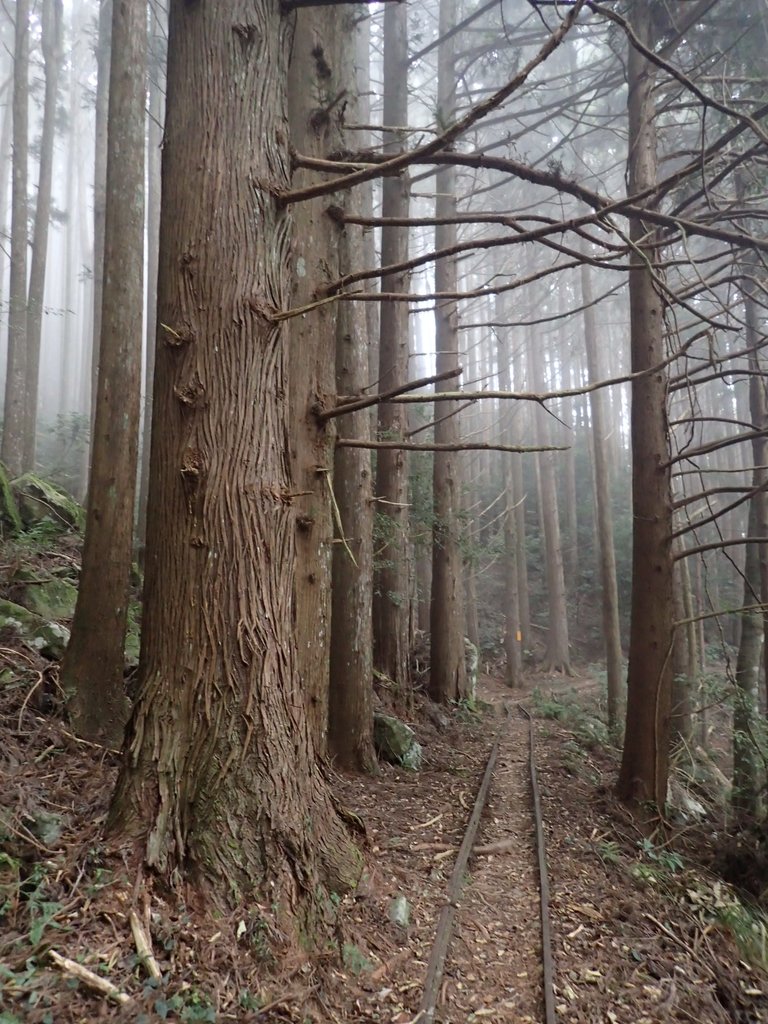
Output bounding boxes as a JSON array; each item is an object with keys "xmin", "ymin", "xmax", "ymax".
[{"xmin": 373, "ymin": 3, "xmax": 411, "ymax": 696}]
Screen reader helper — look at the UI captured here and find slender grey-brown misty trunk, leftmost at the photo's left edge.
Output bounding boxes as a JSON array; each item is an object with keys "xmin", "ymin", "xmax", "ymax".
[{"xmin": 2, "ymin": 0, "xmax": 30, "ymax": 477}]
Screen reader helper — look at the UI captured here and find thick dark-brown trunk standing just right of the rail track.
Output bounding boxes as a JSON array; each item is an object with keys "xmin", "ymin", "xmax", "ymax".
[{"xmin": 617, "ymin": 0, "xmax": 675, "ymax": 810}]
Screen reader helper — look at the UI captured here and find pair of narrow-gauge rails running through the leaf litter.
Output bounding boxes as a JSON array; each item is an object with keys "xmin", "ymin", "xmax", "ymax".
[{"xmin": 411, "ymin": 703, "xmax": 556, "ymax": 1024}]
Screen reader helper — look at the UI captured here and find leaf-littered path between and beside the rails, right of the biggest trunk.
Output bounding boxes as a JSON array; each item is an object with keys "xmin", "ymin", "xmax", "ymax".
[{"xmin": 325, "ymin": 676, "xmax": 768, "ymax": 1024}]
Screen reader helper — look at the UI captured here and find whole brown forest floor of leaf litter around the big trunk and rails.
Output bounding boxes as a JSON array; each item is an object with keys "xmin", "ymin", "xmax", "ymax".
[{"xmin": 0, "ymin": 647, "xmax": 768, "ymax": 1024}]
